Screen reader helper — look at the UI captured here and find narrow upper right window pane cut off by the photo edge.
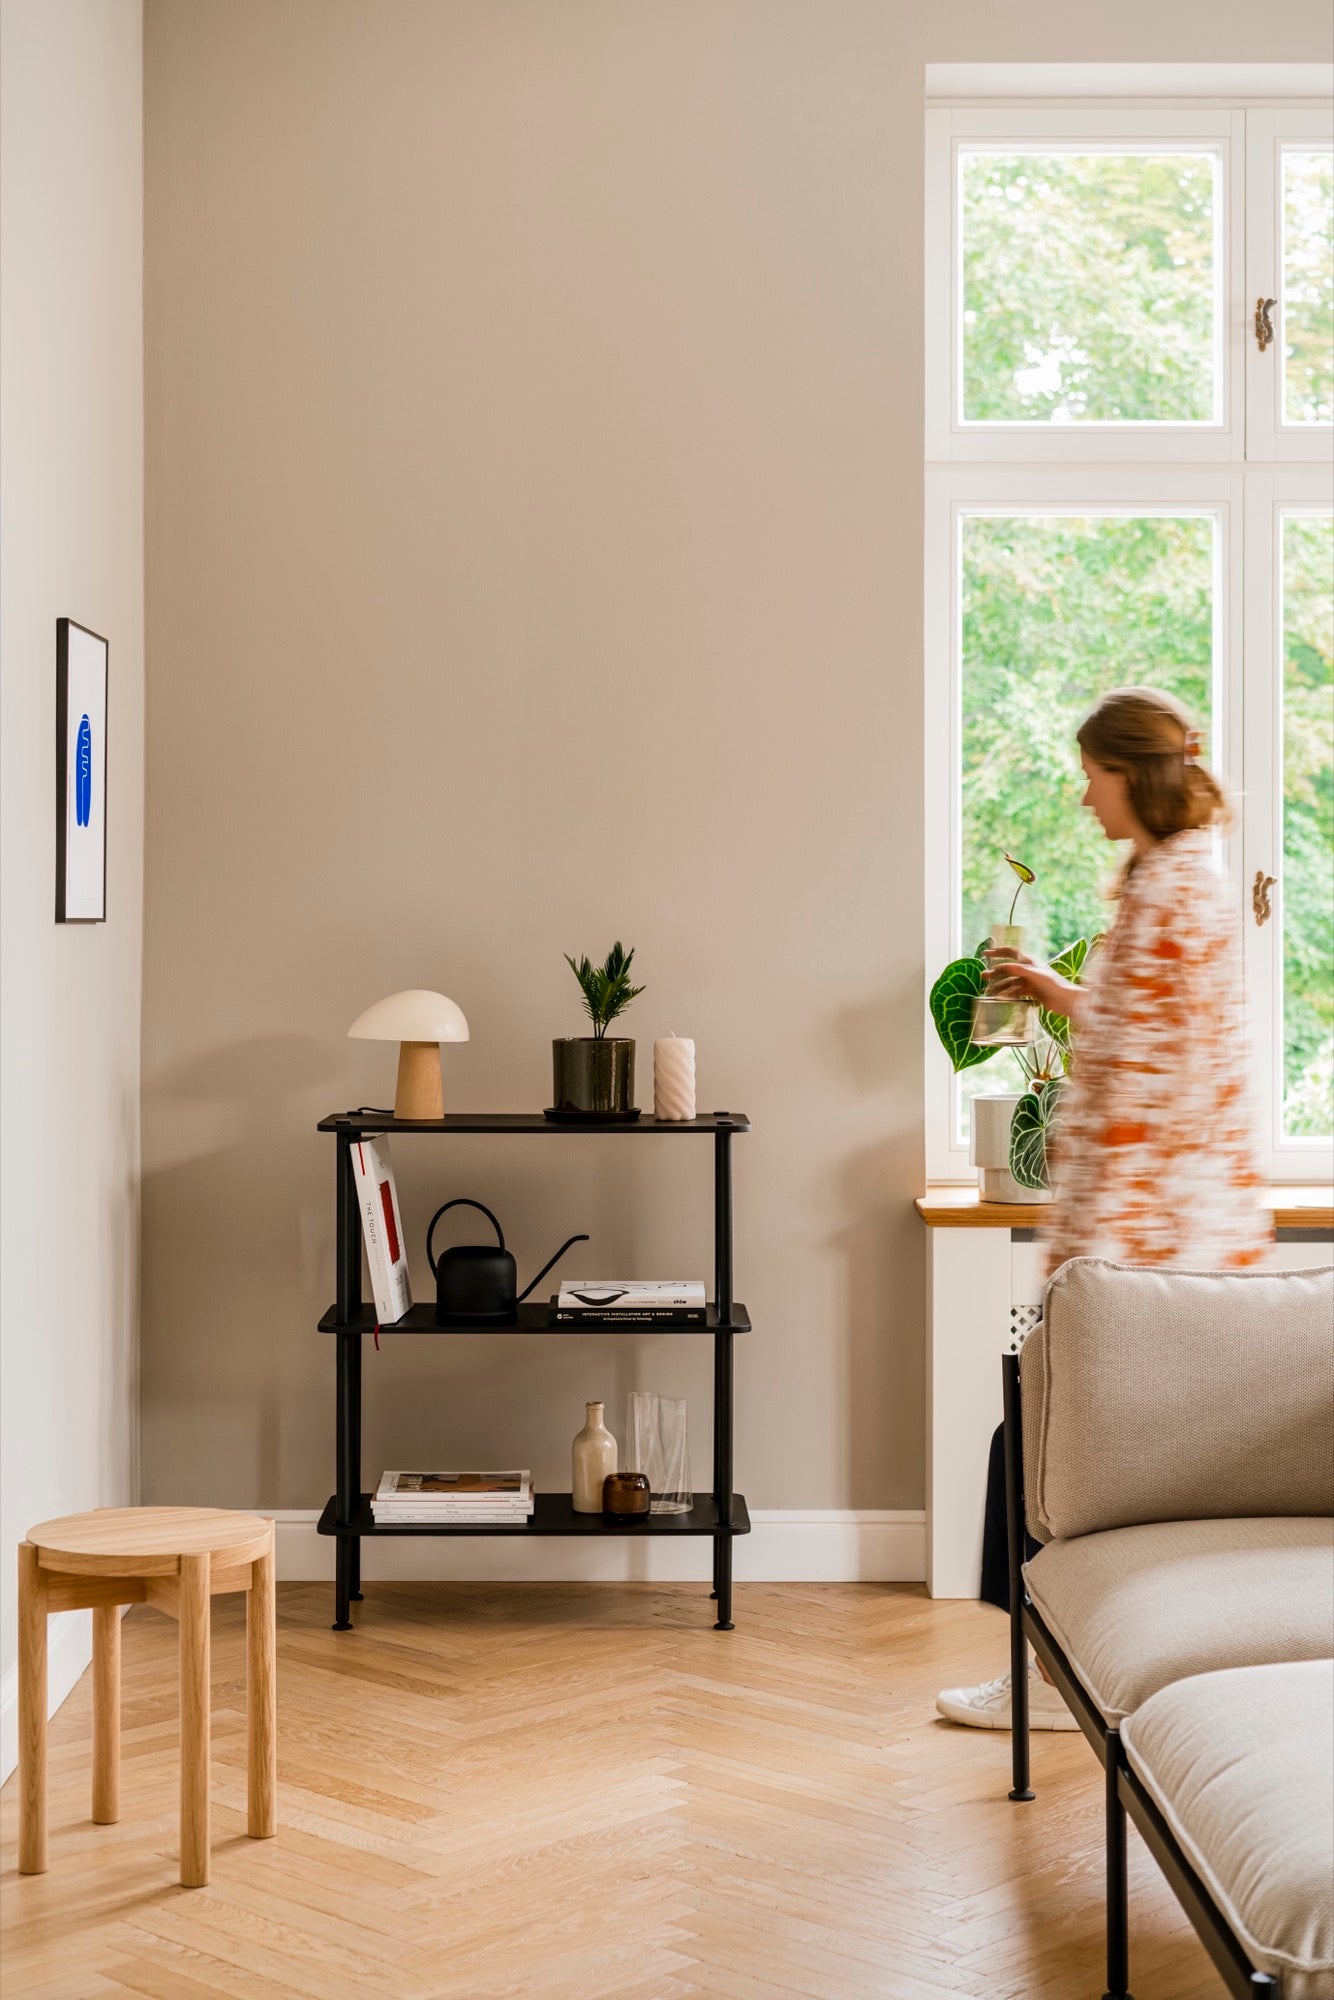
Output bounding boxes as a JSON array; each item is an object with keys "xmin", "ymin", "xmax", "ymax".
[{"xmin": 1282, "ymin": 146, "xmax": 1334, "ymax": 424}]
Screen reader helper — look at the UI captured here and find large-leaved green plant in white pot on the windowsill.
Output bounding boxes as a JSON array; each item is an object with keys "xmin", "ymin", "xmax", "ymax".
[{"xmin": 930, "ymin": 854, "xmax": 1098, "ymax": 1200}]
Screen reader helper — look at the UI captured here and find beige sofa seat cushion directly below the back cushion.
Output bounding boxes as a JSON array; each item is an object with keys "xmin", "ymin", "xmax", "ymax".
[{"xmin": 1024, "ymin": 1520, "xmax": 1334, "ymax": 1722}]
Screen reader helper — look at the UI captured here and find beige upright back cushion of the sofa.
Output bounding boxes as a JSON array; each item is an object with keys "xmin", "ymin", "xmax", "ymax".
[{"xmin": 1020, "ymin": 1258, "xmax": 1334, "ymax": 1538}]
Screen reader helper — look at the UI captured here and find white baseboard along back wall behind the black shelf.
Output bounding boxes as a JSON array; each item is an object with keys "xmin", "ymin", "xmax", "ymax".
[{"xmin": 262, "ymin": 1508, "xmax": 926, "ymax": 1584}]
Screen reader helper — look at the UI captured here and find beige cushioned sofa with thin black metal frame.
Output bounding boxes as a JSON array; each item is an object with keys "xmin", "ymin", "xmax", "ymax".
[{"xmin": 1004, "ymin": 1258, "xmax": 1334, "ymax": 2000}]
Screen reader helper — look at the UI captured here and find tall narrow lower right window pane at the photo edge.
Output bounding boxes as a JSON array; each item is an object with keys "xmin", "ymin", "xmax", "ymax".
[{"xmin": 1282, "ymin": 514, "xmax": 1334, "ymax": 1138}]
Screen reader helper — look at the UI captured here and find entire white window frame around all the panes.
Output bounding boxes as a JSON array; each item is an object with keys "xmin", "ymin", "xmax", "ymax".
[{"xmin": 924, "ymin": 104, "xmax": 1334, "ymax": 1182}]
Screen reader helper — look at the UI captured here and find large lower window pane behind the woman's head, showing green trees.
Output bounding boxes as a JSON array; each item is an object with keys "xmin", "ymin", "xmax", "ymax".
[{"xmin": 958, "ymin": 514, "xmax": 1214, "ymax": 1136}]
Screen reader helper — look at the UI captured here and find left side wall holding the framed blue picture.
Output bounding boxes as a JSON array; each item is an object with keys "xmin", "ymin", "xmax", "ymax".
[{"xmin": 0, "ymin": 0, "xmax": 144, "ymax": 1720}]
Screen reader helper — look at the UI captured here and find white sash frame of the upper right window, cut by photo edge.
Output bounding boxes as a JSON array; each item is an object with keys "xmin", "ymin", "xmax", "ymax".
[{"xmin": 1242, "ymin": 106, "xmax": 1334, "ymax": 466}]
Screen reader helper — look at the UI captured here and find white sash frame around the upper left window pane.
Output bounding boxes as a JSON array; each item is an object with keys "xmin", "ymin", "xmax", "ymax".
[{"xmin": 926, "ymin": 106, "xmax": 1246, "ymax": 464}]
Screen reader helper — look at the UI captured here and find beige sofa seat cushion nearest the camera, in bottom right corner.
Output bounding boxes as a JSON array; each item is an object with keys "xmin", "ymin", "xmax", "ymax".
[{"xmin": 1122, "ymin": 1660, "xmax": 1334, "ymax": 2000}]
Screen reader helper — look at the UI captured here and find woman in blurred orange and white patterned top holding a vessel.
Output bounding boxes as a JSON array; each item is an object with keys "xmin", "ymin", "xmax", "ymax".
[{"xmin": 936, "ymin": 688, "xmax": 1274, "ymax": 1728}]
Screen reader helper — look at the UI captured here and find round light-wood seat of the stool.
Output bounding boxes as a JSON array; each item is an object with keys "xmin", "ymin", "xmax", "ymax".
[{"xmin": 28, "ymin": 1506, "xmax": 274, "ymax": 1576}]
